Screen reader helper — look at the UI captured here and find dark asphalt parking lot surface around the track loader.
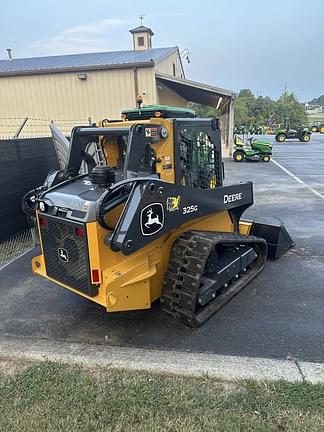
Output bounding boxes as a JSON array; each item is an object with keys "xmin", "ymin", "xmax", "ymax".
[{"xmin": 0, "ymin": 134, "xmax": 324, "ymax": 362}]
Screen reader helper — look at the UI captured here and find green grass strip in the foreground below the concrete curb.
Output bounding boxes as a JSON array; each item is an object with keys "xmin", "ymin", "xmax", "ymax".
[{"xmin": 0, "ymin": 362, "xmax": 324, "ymax": 432}]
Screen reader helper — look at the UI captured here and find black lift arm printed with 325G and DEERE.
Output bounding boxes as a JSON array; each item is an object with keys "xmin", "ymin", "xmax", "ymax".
[{"xmin": 110, "ymin": 179, "xmax": 253, "ymax": 255}]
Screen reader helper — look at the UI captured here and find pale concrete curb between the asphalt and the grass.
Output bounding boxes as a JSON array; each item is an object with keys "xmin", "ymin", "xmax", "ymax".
[{"xmin": 0, "ymin": 337, "xmax": 324, "ymax": 383}]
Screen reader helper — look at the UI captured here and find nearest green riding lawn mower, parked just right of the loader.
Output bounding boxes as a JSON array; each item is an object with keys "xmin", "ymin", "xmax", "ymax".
[{"xmin": 233, "ymin": 135, "xmax": 272, "ymax": 162}]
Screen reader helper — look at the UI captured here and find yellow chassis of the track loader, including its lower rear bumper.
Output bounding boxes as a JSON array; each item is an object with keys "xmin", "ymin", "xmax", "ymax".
[{"xmin": 32, "ymin": 211, "xmax": 251, "ymax": 312}]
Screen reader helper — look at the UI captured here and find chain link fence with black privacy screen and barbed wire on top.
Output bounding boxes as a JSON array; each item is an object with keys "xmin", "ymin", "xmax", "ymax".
[{"xmin": 0, "ymin": 117, "xmax": 91, "ymax": 270}]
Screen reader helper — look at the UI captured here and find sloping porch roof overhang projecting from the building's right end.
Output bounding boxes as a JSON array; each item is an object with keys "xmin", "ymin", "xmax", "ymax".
[{"xmin": 155, "ymin": 73, "xmax": 235, "ymax": 111}]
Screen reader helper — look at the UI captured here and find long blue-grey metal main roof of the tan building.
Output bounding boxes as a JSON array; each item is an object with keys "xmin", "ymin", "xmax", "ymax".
[{"xmin": 0, "ymin": 47, "xmax": 178, "ymax": 76}]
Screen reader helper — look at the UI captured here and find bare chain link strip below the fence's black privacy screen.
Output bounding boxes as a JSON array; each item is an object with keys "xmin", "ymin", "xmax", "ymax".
[{"xmin": 0, "ymin": 228, "xmax": 35, "ymax": 270}]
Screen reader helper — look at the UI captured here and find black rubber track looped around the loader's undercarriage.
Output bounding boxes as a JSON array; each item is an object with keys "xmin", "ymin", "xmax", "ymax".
[{"xmin": 160, "ymin": 231, "xmax": 267, "ymax": 327}]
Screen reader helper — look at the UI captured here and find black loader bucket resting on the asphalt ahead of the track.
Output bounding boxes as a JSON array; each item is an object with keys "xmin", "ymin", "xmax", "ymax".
[{"xmin": 250, "ymin": 221, "xmax": 295, "ymax": 259}]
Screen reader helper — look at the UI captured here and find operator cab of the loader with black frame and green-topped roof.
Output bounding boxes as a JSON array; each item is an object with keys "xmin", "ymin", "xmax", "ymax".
[{"xmin": 50, "ymin": 105, "xmax": 223, "ymax": 189}]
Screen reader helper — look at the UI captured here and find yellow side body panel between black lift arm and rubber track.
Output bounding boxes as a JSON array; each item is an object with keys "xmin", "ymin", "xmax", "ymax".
[{"xmin": 103, "ymin": 211, "xmax": 240, "ymax": 312}]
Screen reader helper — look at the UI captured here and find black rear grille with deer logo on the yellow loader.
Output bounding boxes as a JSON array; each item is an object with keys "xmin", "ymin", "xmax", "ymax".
[{"xmin": 39, "ymin": 214, "xmax": 97, "ymax": 296}]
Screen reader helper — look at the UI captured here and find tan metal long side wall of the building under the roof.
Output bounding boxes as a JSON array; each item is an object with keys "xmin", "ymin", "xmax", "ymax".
[{"xmin": 0, "ymin": 68, "xmax": 135, "ymax": 136}]
